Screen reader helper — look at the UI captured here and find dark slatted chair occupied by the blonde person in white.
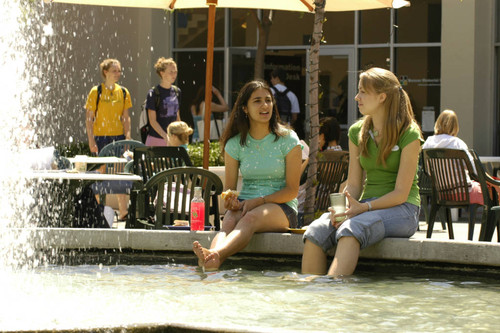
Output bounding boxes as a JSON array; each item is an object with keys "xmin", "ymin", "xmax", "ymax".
[{"xmin": 423, "ymin": 148, "xmax": 487, "ymax": 240}]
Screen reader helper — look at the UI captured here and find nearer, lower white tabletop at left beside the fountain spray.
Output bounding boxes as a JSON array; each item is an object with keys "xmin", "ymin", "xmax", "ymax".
[{"xmin": 25, "ymin": 170, "xmax": 142, "ymax": 182}]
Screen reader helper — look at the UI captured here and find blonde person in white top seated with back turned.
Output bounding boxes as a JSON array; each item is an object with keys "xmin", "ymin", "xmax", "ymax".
[{"xmin": 422, "ymin": 110, "xmax": 484, "ymax": 205}]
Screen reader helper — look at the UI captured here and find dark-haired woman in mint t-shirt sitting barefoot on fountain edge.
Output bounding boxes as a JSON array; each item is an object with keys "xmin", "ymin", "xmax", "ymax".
[{"xmin": 193, "ymin": 80, "xmax": 301, "ymax": 270}]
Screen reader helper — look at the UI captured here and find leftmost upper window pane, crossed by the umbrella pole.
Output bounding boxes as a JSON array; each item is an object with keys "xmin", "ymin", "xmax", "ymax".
[{"xmin": 175, "ymin": 8, "xmax": 224, "ymax": 48}]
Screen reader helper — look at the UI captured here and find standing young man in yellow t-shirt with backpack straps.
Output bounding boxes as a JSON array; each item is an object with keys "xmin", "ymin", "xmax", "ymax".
[{"xmin": 85, "ymin": 59, "xmax": 132, "ymax": 154}]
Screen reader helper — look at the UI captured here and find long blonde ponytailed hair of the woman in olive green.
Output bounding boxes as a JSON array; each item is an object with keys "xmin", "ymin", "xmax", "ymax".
[{"xmin": 359, "ymin": 67, "xmax": 422, "ymax": 166}]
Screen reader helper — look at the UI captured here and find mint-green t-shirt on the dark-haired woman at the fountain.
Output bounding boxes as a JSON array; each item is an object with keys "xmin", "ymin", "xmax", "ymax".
[{"xmin": 225, "ymin": 130, "xmax": 300, "ymax": 211}]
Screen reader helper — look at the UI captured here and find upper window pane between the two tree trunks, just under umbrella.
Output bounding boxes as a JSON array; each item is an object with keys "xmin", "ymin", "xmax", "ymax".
[{"xmin": 268, "ymin": 10, "xmax": 314, "ymax": 46}]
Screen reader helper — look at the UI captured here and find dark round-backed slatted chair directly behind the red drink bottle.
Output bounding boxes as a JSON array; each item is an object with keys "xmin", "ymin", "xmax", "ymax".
[{"xmin": 133, "ymin": 166, "xmax": 223, "ymax": 230}]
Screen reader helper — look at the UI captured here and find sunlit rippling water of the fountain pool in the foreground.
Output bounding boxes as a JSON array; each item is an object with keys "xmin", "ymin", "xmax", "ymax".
[{"xmin": 0, "ymin": 264, "xmax": 500, "ymax": 332}]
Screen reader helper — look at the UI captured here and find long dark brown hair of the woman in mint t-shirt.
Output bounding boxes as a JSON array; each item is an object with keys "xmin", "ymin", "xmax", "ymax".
[{"xmin": 220, "ymin": 80, "xmax": 286, "ymax": 150}]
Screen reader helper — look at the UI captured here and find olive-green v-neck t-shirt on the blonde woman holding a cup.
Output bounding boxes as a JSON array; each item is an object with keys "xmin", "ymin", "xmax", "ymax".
[{"xmin": 349, "ymin": 121, "xmax": 423, "ymax": 206}]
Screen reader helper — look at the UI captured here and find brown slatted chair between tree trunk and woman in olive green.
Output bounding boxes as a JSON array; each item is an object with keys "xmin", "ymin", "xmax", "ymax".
[{"xmin": 314, "ymin": 151, "xmax": 349, "ymax": 212}]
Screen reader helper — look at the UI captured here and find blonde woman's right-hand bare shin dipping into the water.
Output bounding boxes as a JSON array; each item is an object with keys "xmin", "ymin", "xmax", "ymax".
[{"xmin": 328, "ymin": 236, "xmax": 360, "ymax": 277}]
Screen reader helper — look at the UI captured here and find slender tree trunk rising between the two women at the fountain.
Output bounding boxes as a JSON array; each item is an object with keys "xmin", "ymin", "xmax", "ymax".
[{"xmin": 304, "ymin": 0, "xmax": 326, "ymax": 225}]
